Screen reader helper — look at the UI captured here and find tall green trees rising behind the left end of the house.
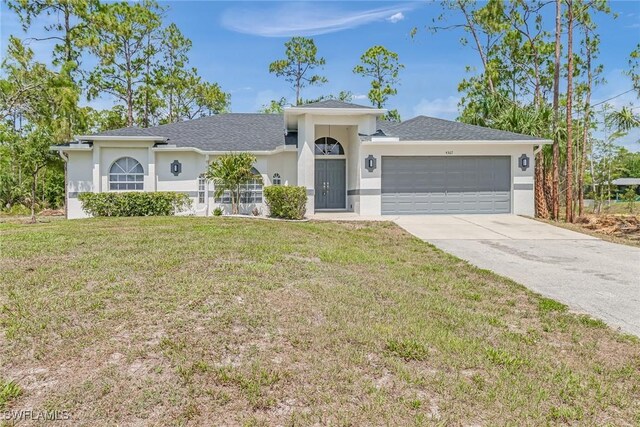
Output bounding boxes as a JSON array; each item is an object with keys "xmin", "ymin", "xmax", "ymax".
[{"xmin": 0, "ymin": 0, "xmax": 230, "ymax": 217}]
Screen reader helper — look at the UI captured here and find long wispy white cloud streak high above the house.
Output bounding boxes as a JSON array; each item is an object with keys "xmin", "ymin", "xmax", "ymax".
[{"xmin": 222, "ymin": 2, "xmax": 414, "ymax": 37}]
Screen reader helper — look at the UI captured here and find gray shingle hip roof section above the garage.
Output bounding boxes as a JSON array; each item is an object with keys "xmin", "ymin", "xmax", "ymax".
[{"xmin": 365, "ymin": 116, "xmax": 542, "ymax": 142}]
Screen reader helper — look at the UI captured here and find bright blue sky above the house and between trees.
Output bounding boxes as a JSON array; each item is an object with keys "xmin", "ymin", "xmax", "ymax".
[{"xmin": 0, "ymin": 1, "xmax": 640, "ymax": 151}]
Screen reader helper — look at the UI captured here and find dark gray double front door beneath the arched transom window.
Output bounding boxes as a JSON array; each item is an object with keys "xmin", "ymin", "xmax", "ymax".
[{"xmin": 315, "ymin": 159, "xmax": 346, "ymax": 209}]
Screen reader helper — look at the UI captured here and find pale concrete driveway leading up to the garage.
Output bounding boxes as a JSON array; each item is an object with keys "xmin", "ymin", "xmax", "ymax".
[{"xmin": 393, "ymin": 215, "xmax": 640, "ymax": 336}]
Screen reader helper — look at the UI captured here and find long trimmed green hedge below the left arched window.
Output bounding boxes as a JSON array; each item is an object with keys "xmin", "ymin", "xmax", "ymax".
[{"xmin": 78, "ymin": 191, "xmax": 191, "ymax": 216}]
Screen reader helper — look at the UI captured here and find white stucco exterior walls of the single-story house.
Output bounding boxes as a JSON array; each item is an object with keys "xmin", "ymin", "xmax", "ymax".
[{"xmin": 58, "ymin": 107, "xmax": 537, "ymax": 218}]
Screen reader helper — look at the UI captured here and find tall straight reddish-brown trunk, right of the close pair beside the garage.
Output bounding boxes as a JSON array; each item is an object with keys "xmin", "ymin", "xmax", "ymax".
[{"xmin": 565, "ymin": 0, "xmax": 573, "ymax": 222}]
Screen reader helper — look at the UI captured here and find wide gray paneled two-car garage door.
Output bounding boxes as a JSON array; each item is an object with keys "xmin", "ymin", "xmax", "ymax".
[{"xmin": 382, "ymin": 156, "xmax": 511, "ymax": 214}]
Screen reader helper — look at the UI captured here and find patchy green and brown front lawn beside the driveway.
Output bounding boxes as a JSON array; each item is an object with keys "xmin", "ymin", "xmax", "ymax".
[{"xmin": 0, "ymin": 217, "xmax": 640, "ymax": 426}]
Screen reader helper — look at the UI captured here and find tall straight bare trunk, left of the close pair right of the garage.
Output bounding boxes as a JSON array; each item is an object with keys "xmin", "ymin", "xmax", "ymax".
[{"xmin": 551, "ymin": 0, "xmax": 562, "ymax": 221}]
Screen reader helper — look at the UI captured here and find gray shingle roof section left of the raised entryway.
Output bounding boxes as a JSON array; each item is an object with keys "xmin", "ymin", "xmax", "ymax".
[{"xmin": 90, "ymin": 113, "xmax": 285, "ymax": 151}]
